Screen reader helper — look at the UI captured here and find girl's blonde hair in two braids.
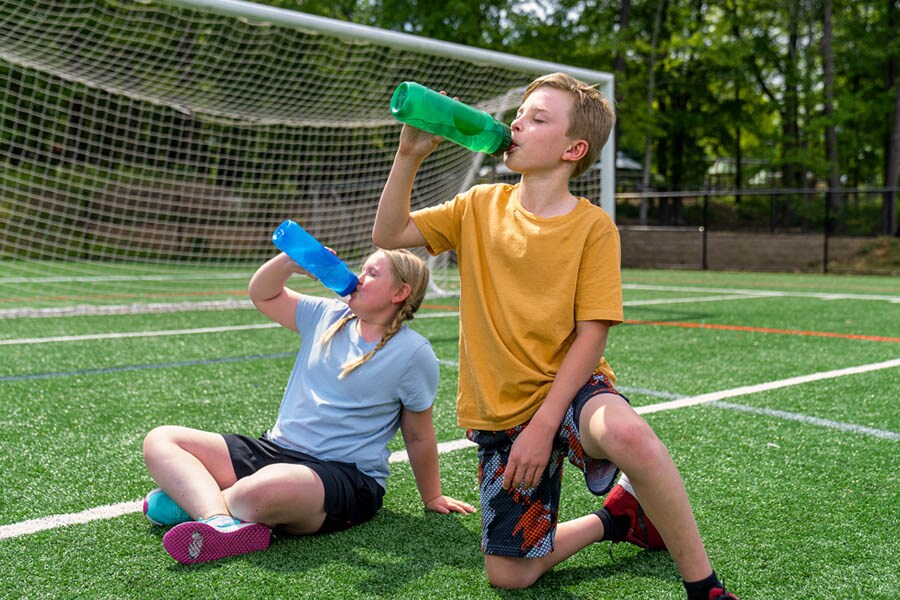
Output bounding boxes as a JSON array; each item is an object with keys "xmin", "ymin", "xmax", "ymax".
[{"xmin": 319, "ymin": 250, "xmax": 429, "ymax": 379}]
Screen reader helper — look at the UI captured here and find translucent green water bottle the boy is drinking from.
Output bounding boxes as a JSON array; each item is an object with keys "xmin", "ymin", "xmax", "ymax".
[{"xmin": 391, "ymin": 81, "xmax": 512, "ymax": 156}]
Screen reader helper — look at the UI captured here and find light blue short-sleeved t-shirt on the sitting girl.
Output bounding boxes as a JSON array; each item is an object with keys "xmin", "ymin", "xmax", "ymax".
[{"xmin": 268, "ymin": 296, "xmax": 438, "ymax": 487}]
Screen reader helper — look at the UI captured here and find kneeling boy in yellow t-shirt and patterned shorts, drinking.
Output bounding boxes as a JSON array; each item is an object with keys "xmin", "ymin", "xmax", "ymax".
[{"xmin": 373, "ymin": 73, "xmax": 735, "ymax": 600}]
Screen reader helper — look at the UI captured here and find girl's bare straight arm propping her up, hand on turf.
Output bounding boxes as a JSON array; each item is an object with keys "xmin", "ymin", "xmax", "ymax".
[{"xmin": 400, "ymin": 408, "xmax": 475, "ymax": 514}]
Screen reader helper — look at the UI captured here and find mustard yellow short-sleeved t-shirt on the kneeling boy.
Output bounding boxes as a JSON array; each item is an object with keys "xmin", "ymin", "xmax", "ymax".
[{"xmin": 412, "ymin": 184, "xmax": 622, "ymax": 431}]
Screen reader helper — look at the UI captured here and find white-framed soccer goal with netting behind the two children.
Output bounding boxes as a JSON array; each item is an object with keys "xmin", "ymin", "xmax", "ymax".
[{"xmin": 0, "ymin": 0, "xmax": 614, "ymax": 308}]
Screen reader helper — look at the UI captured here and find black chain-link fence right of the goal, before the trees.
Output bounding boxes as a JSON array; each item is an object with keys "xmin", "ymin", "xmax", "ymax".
[{"xmin": 616, "ymin": 188, "xmax": 900, "ymax": 274}]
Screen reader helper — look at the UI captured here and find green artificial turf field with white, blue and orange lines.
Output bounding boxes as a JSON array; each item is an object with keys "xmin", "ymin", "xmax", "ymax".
[{"xmin": 0, "ymin": 265, "xmax": 900, "ymax": 600}]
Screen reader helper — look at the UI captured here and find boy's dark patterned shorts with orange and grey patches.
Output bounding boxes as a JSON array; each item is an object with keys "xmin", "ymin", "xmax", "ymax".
[{"xmin": 466, "ymin": 373, "xmax": 627, "ymax": 558}]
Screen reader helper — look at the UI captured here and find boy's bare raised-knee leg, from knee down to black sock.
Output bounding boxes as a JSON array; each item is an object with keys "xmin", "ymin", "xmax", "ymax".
[{"xmin": 579, "ymin": 393, "xmax": 712, "ymax": 581}]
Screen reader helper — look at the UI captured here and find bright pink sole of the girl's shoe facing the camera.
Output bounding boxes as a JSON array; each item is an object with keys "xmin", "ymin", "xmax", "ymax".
[{"xmin": 163, "ymin": 521, "xmax": 272, "ymax": 565}]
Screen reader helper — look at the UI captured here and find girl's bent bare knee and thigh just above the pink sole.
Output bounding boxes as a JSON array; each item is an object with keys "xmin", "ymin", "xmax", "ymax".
[{"xmin": 224, "ymin": 463, "xmax": 325, "ymax": 535}]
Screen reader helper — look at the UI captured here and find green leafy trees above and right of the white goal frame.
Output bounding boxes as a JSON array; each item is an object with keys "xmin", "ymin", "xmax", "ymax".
[{"xmin": 269, "ymin": 0, "xmax": 900, "ymax": 195}]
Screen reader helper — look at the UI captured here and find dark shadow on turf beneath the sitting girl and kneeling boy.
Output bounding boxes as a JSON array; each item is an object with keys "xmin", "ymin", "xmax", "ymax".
[{"xmin": 153, "ymin": 508, "xmax": 680, "ymax": 598}]
